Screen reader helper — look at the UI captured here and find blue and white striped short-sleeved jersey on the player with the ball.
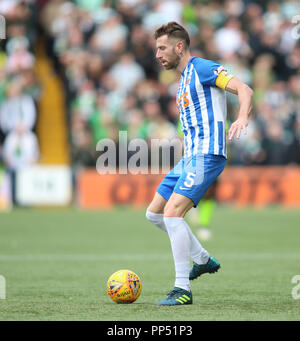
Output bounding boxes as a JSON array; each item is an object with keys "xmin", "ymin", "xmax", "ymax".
[{"xmin": 177, "ymin": 57, "xmax": 233, "ymax": 157}]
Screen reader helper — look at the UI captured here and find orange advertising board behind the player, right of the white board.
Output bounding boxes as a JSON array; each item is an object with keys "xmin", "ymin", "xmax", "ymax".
[{"xmin": 77, "ymin": 167, "xmax": 300, "ymax": 209}]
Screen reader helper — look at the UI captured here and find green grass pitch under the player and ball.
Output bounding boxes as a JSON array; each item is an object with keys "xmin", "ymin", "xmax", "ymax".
[{"xmin": 0, "ymin": 206, "xmax": 300, "ymax": 321}]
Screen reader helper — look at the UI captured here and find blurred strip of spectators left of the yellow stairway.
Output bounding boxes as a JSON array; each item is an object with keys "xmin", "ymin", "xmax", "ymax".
[{"xmin": 0, "ymin": 0, "xmax": 40, "ymax": 177}]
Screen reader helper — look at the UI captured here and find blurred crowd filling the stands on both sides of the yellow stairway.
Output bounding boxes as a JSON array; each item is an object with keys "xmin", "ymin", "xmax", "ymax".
[{"xmin": 0, "ymin": 0, "xmax": 300, "ymax": 167}]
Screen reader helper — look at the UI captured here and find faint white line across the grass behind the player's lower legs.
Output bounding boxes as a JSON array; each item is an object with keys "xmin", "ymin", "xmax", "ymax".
[{"xmin": 0, "ymin": 252, "xmax": 300, "ymax": 262}]
